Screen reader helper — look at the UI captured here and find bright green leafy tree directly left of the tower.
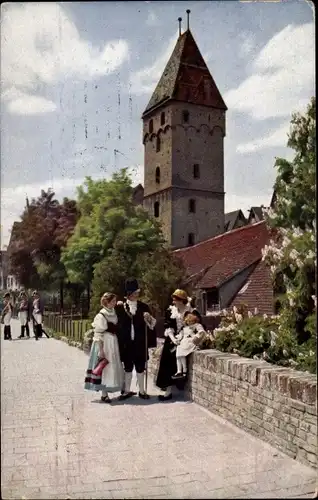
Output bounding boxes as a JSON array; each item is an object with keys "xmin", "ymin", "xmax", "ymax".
[{"xmin": 62, "ymin": 169, "xmax": 164, "ymax": 311}]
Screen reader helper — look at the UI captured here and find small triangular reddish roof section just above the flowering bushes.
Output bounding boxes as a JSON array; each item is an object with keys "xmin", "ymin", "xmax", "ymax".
[{"xmin": 231, "ymin": 261, "xmax": 274, "ymax": 315}]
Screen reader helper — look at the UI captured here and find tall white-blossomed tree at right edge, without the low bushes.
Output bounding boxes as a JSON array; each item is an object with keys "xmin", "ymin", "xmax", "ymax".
[{"xmin": 263, "ymin": 98, "xmax": 316, "ymax": 344}]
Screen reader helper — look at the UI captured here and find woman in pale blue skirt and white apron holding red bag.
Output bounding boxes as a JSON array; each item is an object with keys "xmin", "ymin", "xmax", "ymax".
[{"xmin": 84, "ymin": 292, "xmax": 123, "ymax": 403}]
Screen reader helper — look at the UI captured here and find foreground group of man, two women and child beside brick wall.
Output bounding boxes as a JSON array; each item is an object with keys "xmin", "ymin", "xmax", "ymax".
[{"xmin": 84, "ymin": 278, "xmax": 205, "ymax": 403}]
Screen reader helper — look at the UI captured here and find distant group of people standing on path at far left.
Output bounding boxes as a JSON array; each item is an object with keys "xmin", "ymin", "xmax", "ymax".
[{"xmin": 1, "ymin": 291, "xmax": 43, "ymax": 340}]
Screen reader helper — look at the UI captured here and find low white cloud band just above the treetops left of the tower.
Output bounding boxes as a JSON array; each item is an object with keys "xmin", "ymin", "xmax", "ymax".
[{"xmin": 0, "ymin": 165, "xmax": 143, "ymax": 248}]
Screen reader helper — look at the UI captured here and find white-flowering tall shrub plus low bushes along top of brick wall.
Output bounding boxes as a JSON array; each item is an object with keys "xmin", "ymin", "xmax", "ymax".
[{"xmin": 209, "ymin": 98, "xmax": 317, "ymax": 372}]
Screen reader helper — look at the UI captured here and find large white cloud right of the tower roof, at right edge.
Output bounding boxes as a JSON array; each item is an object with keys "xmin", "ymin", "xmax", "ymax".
[{"xmin": 224, "ymin": 23, "xmax": 315, "ymax": 120}]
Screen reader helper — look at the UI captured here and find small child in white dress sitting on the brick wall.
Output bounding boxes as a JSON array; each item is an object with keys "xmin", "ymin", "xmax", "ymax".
[{"xmin": 172, "ymin": 310, "xmax": 205, "ymax": 378}]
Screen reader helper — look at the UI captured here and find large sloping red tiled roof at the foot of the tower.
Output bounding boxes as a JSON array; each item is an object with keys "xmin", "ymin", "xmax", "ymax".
[{"xmin": 174, "ymin": 221, "xmax": 270, "ymax": 288}]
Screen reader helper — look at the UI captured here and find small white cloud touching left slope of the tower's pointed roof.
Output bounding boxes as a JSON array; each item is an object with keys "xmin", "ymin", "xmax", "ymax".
[{"xmin": 130, "ymin": 31, "xmax": 179, "ymax": 94}]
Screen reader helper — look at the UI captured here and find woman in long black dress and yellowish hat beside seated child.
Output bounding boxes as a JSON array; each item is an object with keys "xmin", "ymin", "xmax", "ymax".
[{"xmin": 156, "ymin": 289, "xmax": 192, "ymax": 401}]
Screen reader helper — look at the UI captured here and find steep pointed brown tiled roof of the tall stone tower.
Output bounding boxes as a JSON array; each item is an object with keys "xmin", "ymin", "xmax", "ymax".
[{"xmin": 143, "ymin": 29, "xmax": 227, "ymax": 116}]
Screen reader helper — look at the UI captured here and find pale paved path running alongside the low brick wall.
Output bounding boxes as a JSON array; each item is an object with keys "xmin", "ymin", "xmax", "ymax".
[{"xmin": 1, "ymin": 321, "xmax": 316, "ymax": 499}]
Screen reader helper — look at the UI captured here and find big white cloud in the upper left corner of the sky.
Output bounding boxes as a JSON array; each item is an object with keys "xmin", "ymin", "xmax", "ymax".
[{"xmin": 1, "ymin": 2, "xmax": 128, "ymax": 114}]
